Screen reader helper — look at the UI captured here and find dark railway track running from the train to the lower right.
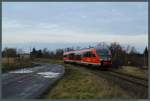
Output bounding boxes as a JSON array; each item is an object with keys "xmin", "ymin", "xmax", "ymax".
[{"xmin": 70, "ymin": 66, "xmax": 148, "ymax": 98}]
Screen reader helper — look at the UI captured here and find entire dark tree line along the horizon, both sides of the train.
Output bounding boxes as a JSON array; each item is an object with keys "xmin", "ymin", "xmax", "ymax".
[{"xmin": 2, "ymin": 42, "xmax": 148, "ymax": 67}]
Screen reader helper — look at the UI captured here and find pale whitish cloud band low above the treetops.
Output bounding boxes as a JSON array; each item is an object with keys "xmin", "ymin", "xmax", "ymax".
[{"xmin": 2, "ymin": 21, "xmax": 148, "ymax": 45}]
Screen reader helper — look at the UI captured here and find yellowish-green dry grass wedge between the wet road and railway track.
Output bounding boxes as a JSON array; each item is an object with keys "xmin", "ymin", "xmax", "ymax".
[{"xmin": 45, "ymin": 60, "xmax": 134, "ymax": 99}]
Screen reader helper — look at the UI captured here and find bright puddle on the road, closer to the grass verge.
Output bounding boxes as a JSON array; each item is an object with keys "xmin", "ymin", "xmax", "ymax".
[{"xmin": 37, "ymin": 72, "xmax": 60, "ymax": 78}]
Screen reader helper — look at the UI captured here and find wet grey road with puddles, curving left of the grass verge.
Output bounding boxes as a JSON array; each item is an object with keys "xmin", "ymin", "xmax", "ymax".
[{"xmin": 2, "ymin": 64, "xmax": 64, "ymax": 98}]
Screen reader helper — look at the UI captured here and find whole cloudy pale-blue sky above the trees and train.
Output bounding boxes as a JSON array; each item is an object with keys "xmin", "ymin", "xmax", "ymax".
[{"xmin": 2, "ymin": 2, "xmax": 148, "ymax": 52}]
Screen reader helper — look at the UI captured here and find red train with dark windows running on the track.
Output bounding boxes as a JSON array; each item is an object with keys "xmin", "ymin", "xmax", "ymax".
[{"xmin": 63, "ymin": 48, "xmax": 112, "ymax": 67}]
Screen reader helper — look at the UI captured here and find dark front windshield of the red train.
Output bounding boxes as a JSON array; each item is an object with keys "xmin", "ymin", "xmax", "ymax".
[{"xmin": 96, "ymin": 49, "xmax": 111, "ymax": 60}]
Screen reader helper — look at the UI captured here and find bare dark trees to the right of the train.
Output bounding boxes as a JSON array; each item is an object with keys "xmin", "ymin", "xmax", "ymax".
[{"xmin": 109, "ymin": 43, "xmax": 148, "ymax": 67}]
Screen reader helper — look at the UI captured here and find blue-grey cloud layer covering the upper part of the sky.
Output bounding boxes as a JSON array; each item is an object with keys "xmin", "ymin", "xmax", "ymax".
[{"xmin": 3, "ymin": 2, "xmax": 148, "ymax": 35}]
